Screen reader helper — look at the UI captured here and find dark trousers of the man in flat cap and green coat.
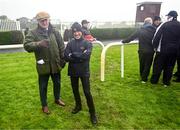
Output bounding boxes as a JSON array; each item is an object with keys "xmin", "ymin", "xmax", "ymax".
[{"xmin": 39, "ymin": 73, "xmax": 61, "ymax": 107}]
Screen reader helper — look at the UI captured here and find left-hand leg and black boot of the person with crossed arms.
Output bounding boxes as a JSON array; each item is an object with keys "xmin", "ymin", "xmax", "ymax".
[{"xmin": 71, "ymin": 76, "xmax": 82, "ymax": 114}]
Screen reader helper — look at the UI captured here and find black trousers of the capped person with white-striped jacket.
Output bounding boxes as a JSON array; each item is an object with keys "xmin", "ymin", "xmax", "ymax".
[{"xmin": 151, "ymin": 52, "xmax": 177, "ymax": 85}]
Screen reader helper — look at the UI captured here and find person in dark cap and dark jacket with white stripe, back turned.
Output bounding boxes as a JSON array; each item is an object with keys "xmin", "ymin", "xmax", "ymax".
[{"xmin": 151, "ymin": 11, "xmax": 180, "ymax": 87}]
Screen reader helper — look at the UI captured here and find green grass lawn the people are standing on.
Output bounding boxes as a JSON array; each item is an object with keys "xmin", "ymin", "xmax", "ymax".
[{"xmin": 0, "ymin": 45, "xmax": 180, "ymax": 129}]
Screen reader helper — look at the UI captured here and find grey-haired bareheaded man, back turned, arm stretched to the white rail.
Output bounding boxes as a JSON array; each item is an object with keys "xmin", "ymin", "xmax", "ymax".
[{"xmin": 122, "ymin": 17, "xmax": 156, "ymax": 83}]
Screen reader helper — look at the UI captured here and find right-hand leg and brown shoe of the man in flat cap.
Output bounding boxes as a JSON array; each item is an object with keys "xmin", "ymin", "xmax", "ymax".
[{"xmin": 51, "ymin": 73, "xmax": 65, "ymax": 106}]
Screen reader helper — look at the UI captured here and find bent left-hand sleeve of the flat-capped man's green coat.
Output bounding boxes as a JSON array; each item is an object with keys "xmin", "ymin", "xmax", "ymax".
[{"xmin": 24, "ymin": 31, "xmax": 39, "ymax": 52}]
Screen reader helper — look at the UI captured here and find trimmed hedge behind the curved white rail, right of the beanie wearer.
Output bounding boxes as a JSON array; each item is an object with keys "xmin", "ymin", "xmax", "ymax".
[{"xmin": 90, "ymin": 28, "xmax": 137, "ymax": 40}]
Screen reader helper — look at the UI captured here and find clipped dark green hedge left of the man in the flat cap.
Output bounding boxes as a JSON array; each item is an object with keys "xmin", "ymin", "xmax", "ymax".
[{"xmin": 0, "ymin": 31, "xmax": 24, "ymax": 45}]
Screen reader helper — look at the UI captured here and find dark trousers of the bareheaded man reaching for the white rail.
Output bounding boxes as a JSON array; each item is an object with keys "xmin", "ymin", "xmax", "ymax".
[{"xmin": 138, "ymin": 51, "xmax": 154, "ymax": 81}]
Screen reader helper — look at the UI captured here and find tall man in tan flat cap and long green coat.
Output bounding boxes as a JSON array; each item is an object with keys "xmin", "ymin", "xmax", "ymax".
[{"xmin": 24, "ymin": 12, "xmax": 65, "ymax": 114}]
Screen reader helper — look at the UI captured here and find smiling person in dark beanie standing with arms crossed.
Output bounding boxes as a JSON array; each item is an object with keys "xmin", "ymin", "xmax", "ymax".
[{"xmin": 64, "ymin": 22, "xmax": 97, "ymax": 124}]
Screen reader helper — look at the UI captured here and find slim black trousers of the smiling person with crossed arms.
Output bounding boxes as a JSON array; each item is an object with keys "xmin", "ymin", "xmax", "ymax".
[{"xmin": 71, "ymin": 76, "xmax": 95, "ymax": 114}]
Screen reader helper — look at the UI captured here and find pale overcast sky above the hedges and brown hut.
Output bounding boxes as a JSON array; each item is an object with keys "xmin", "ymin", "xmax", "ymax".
[{"xmin": 0, "ymin": 0, "xmax": 180, "ymax": 21}]
